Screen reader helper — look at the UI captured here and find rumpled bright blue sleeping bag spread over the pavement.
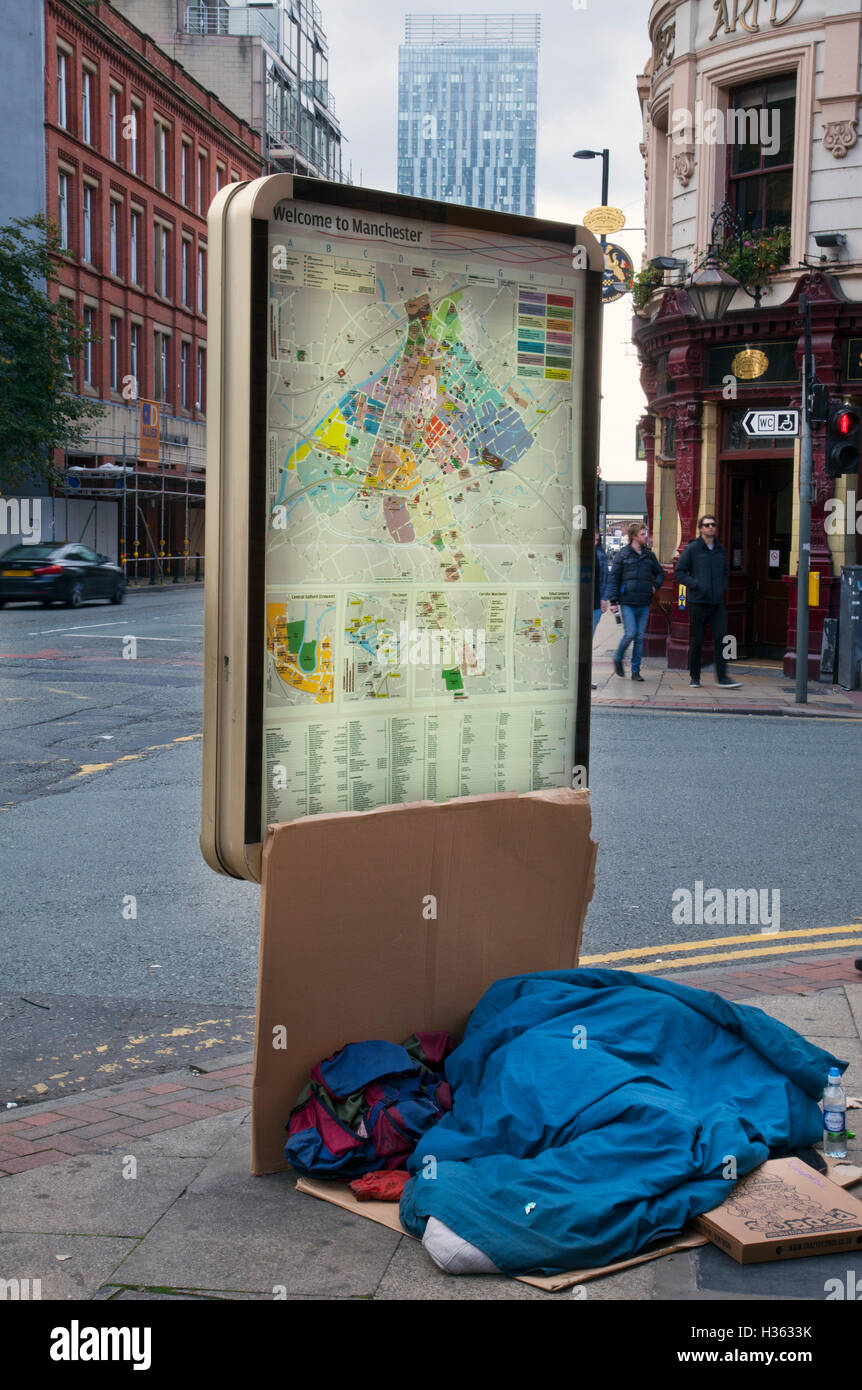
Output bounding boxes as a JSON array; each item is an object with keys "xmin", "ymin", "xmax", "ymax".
[{"xmin": 400, "ymin": 969, "xmax": 847, "ymax": 1275}]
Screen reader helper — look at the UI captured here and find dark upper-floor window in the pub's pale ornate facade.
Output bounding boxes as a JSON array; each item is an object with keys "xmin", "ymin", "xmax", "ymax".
[{"xmin": 726, "ymin": 75, "xmax": 797, "ymax": 231}]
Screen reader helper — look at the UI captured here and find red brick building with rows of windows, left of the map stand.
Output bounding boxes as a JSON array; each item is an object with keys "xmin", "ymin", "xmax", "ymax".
[{"xmin": 44, "ymin": 0, "xmax": 263, "ymax": 577}]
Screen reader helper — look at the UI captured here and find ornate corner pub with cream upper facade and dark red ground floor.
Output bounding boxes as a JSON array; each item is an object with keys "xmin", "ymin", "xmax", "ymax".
[{"xmin": 633, "ymin": 0, "xmax": 862, "ymax": 677}]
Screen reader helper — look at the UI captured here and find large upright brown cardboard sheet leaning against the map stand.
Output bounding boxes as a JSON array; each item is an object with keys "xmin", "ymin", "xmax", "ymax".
[{"xmin": 252, "ymin": 788, "xmax": 598, "ymax": 1173}]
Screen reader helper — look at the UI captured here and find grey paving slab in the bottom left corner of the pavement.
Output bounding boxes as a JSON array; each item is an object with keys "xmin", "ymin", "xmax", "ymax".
[{"xmin": 0, "ymin": 1232, "xmax": 135, "ymax": 1295}]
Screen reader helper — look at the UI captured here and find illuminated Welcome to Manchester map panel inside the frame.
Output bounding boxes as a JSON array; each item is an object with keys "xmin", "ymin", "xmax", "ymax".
[{"xmin": 263, "ymin": 202, "xmax": 585, "ymax": 821}]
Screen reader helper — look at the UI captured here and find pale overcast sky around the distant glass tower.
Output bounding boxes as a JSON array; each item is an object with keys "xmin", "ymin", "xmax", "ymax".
[{"xmin": 317, "ymin": 0, "xmax": 649, "ymax": 480}]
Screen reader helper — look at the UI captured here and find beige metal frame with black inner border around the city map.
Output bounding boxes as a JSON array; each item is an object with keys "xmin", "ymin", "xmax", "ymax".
[{"xmin": 200, "ymin": 174, "xmax": 603, "ymax": 881}]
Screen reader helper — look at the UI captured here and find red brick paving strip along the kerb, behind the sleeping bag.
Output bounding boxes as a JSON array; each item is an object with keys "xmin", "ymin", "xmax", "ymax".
[{"xmin": 0, "ymin": 954, "xmax": 862, "ymax": 1177}]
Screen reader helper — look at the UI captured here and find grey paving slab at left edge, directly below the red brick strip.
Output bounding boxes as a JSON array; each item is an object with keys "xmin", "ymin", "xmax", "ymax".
[{"xmin": 3, "ymin": 1150, "xmax": 203, "ymax": 1236}]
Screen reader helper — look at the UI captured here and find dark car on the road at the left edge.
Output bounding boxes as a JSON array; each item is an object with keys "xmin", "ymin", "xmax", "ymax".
[{"xmin": 0, "ymin": 541, "xmax": 125, "ymax": 607}]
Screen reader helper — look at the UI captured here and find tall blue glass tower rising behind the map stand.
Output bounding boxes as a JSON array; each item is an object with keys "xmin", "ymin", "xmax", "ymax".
[{"xmin": 398, "ymin": 14, "xmax": 541, "ymax": 215}]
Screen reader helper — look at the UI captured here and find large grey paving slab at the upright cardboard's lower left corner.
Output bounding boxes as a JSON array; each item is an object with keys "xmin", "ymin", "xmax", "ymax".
[{"xmin": 113, "ymin": 1133, "xmax": 399, "ymax": 1298}]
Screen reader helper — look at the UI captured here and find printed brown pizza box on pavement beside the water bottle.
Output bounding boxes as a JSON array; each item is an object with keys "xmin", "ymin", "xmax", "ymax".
[{"xmin": 695, "ymin": 1158, "xmax": 862, "ymax": 1265}]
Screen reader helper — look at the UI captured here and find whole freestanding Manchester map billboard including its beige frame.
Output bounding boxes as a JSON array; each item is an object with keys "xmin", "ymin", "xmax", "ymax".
[{"xmin": 202, "ymin": 175, "xmax": 602, "ymax": 877}]
